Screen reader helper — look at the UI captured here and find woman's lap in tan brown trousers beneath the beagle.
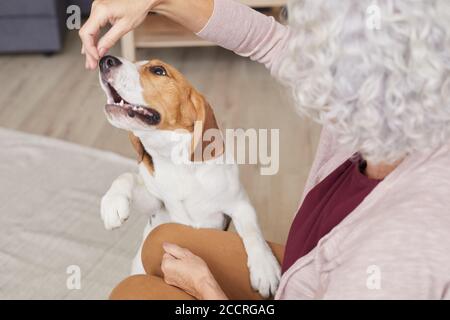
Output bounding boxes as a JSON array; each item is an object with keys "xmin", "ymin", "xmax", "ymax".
[{"xmin": 111, "ymin": 224, "xmax": 284, "ymax": 300}]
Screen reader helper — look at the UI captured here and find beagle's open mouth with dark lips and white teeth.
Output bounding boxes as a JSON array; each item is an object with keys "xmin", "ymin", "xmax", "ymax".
[{"xmin": 105, "ymin": 83, "xmax": 161, "ymax": 125}]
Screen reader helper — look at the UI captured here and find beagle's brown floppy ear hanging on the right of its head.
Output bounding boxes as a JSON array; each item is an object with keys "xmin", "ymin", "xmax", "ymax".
[{"xmin": 190, "ymin": 89, "xmax": 224, "ymax": 162}]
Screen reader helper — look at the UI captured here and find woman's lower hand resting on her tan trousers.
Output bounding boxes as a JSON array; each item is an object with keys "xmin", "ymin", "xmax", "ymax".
[{"xmin": 161, "ymin": 243, "xmax": 227, "ymax": 300}]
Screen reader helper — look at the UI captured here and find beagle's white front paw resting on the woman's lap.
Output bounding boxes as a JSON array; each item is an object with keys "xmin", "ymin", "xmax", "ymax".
[{"xmin": 248, "ymin": 248, "xmax": 281, "ymax": 298}]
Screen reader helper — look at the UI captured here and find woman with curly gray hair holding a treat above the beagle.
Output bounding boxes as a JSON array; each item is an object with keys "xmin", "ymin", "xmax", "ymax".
[{"xmin": 80, "ymin": 0, "xmax": 450, "ymax": 299}]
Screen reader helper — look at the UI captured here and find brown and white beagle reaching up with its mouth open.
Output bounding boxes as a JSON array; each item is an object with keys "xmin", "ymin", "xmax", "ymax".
[{"xmin": 99, "ymin": 56, "xmax": 280, "ymax": 297}]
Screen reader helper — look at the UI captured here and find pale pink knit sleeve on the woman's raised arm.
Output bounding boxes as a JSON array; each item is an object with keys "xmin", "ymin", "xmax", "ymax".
[{"xmin": 197, "ymin": 0, "xmax": 290, "ymax": 75}]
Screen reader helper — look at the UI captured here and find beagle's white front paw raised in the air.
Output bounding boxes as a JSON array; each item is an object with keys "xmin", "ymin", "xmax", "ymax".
[{"xmin": 100, "ymin": 193, "xmax": 130, "ymax": 230}]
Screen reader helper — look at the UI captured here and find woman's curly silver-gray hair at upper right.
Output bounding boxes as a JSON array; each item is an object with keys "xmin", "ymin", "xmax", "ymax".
[{"xmin": 279, "ymin": 0, "xmax": 450, "ymax": 163}]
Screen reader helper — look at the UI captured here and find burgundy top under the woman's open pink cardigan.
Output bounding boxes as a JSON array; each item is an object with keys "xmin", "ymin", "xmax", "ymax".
[{"xmin": 282, "ymin": 157, "xmax": 380, "ymax": 272}]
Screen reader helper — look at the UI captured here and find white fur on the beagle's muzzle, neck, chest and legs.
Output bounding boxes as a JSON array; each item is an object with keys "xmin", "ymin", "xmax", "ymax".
[{"xmin": 100, "ymin": 59, "xmax": 280, "ymax": 297}]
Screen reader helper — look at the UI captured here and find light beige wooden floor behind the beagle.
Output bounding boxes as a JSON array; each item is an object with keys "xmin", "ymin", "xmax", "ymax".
[{"xmin": 0, "ymin": 33, "xmax": 319, "ymax": 243}]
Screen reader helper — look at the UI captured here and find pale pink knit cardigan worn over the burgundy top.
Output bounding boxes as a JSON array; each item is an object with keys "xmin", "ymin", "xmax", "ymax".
[{"xmin": 198, "ymin": 0, "xmax": 450, "ymax": 299}]
